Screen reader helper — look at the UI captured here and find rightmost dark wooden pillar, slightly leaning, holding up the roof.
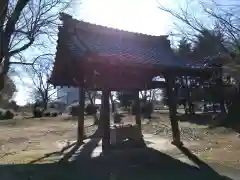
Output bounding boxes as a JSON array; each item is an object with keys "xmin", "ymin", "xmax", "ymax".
[{"xmin": 165, "ymin": 74, "xmax": 183, "ymax": 146}]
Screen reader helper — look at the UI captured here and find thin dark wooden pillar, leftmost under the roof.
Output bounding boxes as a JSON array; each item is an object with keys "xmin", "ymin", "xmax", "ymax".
[{"xmin": 77, "ymin": 88, "xmax": 85, "ymax": 144}]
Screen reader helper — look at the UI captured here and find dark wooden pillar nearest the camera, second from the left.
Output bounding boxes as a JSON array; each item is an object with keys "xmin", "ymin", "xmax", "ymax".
[{"xmin": 101, "ymin": 89, "xmax": 111, "ymax": 153}]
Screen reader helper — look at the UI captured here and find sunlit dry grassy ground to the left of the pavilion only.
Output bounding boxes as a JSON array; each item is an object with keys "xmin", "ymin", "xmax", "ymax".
[{"xmin": 0, "ymin": 117, "xmax": 96, "ymax": 164}]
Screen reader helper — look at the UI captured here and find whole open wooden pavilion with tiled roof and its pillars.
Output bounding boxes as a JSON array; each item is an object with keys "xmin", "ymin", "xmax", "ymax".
[{"xmin": 50, "ymin": 13, "xmax": 212, "ymax": 151}]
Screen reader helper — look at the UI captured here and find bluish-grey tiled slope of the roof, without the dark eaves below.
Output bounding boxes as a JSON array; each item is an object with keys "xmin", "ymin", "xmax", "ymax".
[{"xmin": 60, "ymin": 14, "xmax": 194, "ymax": 68}]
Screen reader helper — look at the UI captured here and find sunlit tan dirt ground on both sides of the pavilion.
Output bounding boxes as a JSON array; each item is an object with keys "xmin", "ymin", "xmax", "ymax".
[{"xmin": 0, "ymin": 113, "xmax": 240, "ymax": 169}]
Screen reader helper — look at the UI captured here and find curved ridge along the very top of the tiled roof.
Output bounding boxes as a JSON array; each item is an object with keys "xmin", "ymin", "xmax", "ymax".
[{"xmin": 60, "ymin": 13, "xmax": 168, "ymax": 40}]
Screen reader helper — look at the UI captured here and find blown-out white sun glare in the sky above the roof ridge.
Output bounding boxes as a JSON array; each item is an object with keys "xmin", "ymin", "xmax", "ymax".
[{"xmin": 76, "ymin": 0, "xmax": 170, "ymax": 35}]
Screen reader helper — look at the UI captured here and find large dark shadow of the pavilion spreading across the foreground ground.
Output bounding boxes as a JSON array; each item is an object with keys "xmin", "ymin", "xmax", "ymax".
[{"xmin": 0, "ymin": 131, "xmax": 230, "ymax": 180}]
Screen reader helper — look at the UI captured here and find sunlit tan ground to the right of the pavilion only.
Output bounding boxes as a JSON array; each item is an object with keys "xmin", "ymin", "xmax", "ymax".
[{"xmin": 144, "ymin": 113, "xmax": 240, "ymax": 169}]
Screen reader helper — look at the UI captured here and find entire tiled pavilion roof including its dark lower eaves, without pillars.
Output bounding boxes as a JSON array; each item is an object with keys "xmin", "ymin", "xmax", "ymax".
[{"xmin": 49, "ymin": 14, "xmax": 218, "ymax": 87}]
